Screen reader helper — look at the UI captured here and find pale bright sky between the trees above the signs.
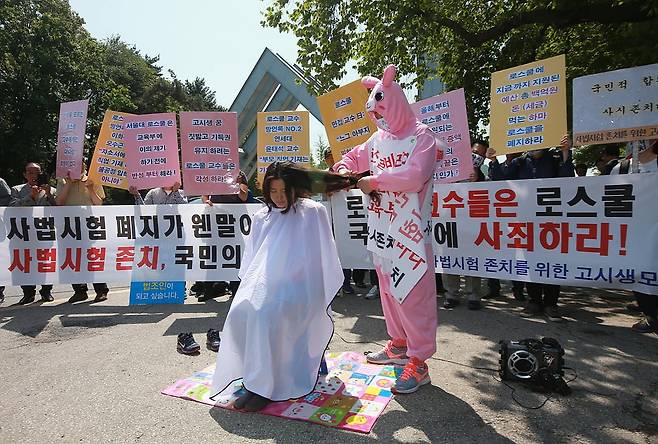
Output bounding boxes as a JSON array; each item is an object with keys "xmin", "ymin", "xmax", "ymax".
[{"xmin": 69, "ymin": 0, "xmax": 330, "ymax": 158}]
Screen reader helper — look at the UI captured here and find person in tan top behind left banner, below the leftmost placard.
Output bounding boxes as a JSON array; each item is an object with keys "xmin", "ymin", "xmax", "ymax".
[{"xmin": 57, "ymin": 159, "xmax": 110, "ymax": 304}]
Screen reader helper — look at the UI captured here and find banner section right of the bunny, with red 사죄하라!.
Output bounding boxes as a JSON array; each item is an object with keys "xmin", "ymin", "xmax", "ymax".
[{"xmin": 432, "ymin": 173, "xmax": 658, "ymax": 295}]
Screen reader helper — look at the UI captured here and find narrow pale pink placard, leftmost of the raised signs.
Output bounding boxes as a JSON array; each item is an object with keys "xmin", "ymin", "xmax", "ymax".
[{"xmin": 55, "ymin": 100, "xmax": 89, "ymax": 179}]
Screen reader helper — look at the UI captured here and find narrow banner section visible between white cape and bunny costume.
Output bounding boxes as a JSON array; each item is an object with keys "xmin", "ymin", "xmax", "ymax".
[{"xmin": 331, "ymin": 190, "xmax": 374, "ymax": 269}]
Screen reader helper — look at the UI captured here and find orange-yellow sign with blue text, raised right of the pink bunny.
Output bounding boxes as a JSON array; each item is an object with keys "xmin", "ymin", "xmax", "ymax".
[{"xmin": 489, "ymin": 55, "xmax": 567, "ymax": 155}]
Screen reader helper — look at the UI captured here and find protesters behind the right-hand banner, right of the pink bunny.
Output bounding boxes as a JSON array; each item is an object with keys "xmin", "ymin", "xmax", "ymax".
[{"xmin": 334, "ymin": 135, "xmax": 658, "ymax": 333}]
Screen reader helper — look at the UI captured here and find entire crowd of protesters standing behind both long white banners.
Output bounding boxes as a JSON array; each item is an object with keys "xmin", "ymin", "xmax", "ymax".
[{"xmin": 0, "ymin": 136, "xmax": 658, "ymax": 333}]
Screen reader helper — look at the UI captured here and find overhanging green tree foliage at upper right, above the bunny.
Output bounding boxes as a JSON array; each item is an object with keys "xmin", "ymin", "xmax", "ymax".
[{"xmin": 262, "ymin": 0, "xmax": 658, "ymax": 139}]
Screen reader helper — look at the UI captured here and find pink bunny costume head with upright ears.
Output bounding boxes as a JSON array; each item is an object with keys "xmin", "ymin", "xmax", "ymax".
[{"xmin": 361, "ymin": 65, "xmax": 416, "ymax": 136}]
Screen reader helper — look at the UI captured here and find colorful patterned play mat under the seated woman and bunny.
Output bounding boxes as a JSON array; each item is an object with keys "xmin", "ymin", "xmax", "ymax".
[{"xmin": 162, "ymin": 352, "xmax": 402, "ymax": 433}]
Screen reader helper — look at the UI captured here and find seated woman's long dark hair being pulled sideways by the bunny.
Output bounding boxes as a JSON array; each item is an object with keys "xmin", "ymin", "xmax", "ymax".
[{"xmin": 263, "ymin": 162, "xmax": 359, "ymax": 214}]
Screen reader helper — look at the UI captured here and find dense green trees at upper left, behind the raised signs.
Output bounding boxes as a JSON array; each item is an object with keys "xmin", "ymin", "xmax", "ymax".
[{"xmin": 0, "ymin": 0, "xmax": 224, "ymax": 186}]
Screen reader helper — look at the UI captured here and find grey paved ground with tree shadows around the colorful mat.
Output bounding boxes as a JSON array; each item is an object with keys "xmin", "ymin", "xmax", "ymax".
[{"xmin": 0, "ymin": 286, "xmax": 658, "ymax": 443}]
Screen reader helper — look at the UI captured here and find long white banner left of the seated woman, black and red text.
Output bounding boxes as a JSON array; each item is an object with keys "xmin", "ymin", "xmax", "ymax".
[{"xmin": 0, "ymin": 204, "xmax": 262, "ymax": 285}]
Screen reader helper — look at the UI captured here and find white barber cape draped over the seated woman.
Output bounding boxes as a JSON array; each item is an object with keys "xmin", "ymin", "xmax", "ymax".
[{"xmin": 213, "ymin": 199, "xmax": 343, "ymax": 401}]
